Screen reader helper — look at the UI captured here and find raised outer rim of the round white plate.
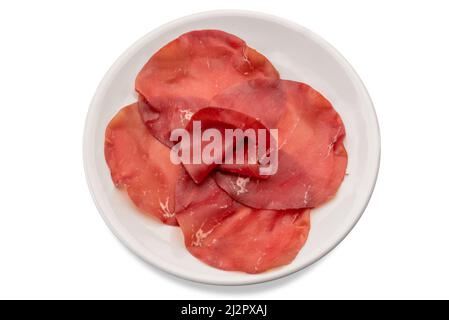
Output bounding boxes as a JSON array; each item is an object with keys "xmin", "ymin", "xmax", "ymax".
[{"xmin": 83, "ymin": 10, "xmax": 381, "ymax": 286}]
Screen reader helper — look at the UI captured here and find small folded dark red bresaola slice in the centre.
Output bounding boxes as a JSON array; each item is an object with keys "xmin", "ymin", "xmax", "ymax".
[{"xmin": 179, "ymin": 107, "xmax": 270, "ymax": 183}]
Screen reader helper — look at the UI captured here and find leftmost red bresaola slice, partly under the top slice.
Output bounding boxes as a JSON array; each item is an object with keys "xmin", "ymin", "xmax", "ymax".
[{"xmin": 104, "ymin": 104, "xmax": 182, "ymax": 225}]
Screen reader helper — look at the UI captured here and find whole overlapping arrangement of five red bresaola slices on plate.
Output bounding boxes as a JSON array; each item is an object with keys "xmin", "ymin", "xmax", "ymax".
[{"xmin": 105, "ymin": 30, "xmax": 347, "ymax": 273}]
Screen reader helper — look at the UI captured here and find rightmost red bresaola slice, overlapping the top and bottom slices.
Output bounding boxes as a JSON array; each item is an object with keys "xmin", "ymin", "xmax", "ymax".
[{"xmin": 211, "ymin": 80, "xmax": 347, "ymax": 210}]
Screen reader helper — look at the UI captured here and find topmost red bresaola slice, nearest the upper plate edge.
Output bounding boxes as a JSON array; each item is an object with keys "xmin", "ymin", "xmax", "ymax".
[{"xmin": 135, "ymin": 30, "xmax": 279, "ymax": 146}]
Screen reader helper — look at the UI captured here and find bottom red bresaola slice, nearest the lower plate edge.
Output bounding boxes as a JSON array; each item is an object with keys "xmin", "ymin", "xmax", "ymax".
[{"xmin": 176, "ymin": 174, "xmax": 310, "ymax": 273}]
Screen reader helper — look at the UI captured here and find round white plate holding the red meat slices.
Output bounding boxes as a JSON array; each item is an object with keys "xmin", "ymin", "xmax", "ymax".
[{"xmin": 84, "ymin": 11, "xmax": 380, "ymax": 285}]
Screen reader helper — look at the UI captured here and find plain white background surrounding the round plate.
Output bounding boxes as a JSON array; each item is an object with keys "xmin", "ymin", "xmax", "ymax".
[{"xmin": 0, "ymin": 0, "xmax": 449, "ymax": 299}]
